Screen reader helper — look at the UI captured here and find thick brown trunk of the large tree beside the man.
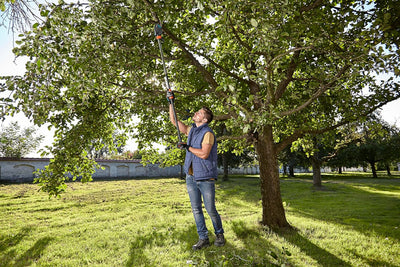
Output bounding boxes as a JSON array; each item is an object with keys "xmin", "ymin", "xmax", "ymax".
[{"xmin": 255, "ymin": 126, "xmax": 290, "ymax": 228}]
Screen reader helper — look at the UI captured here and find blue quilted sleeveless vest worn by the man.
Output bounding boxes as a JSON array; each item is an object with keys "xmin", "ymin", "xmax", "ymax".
[{"xmin": 184, "ymin": 123, "xmax": 218, "ymax": 181}]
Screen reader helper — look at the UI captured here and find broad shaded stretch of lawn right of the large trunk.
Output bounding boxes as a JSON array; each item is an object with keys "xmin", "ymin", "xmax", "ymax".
[{"xmin": 282, "ymin": 179, "xmax": 400, "ymax": 241}]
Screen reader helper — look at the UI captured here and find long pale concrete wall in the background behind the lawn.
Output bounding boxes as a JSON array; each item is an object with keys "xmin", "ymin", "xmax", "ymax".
[{"xmin": 0, "ymin": 158, "xmax": 260, "ymax": 182}]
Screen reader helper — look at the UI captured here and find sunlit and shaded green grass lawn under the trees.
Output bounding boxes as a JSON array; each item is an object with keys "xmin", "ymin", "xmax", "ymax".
[{"xmin": 0, "ymin": 173, "xmax": 400, "ymax": 266}]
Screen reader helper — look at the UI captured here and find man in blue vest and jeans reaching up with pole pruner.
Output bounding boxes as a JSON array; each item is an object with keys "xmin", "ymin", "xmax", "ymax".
[{"xmin": 169, "ymin": 105, "xmax": 225, "ymax": 250}]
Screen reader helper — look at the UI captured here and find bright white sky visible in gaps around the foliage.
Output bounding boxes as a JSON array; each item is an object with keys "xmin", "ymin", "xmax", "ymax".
[{"xmin": 0, "ymin": 9, "xmax": 400, "ymax": 156}]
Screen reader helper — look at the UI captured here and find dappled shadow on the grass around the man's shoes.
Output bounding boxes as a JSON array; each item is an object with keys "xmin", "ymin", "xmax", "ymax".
[{"xmin": 126, "ymin": 221, "xmax": 287, "ymax": 267}]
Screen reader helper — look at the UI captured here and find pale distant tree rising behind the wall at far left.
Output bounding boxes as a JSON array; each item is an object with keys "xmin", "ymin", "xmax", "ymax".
[{"xmin": 0, "ymin": 122, "xmax": 44, "ymax": 158}]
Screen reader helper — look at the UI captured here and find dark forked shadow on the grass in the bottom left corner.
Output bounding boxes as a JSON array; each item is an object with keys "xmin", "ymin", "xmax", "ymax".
[{"xmin": 0, "ymin": 227, "xmax": 53, "ymax": 267}]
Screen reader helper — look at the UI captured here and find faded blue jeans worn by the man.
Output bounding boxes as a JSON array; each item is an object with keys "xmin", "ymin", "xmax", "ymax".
[{"xmin": 186, "ymin": 175, "xmax": 224, "ymax": 239}]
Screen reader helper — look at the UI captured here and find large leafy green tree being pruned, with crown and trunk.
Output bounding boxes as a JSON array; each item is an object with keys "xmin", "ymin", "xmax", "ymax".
[{"xmin": 3, "ymin": 0, "xmax": 400, "ymax": 228}]
